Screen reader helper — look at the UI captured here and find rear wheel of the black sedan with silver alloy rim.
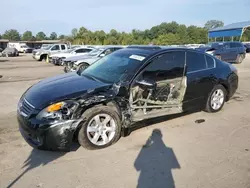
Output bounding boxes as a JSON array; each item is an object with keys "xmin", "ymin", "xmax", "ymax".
[{"xmin": 205, "ymin": 84, "xmax": 227, "ymax": 113}]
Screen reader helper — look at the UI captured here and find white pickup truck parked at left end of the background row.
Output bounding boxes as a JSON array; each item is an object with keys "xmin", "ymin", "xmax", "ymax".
[{"xmin": 33, "ymin": 44, "xmax": 68, "ymax": 61}]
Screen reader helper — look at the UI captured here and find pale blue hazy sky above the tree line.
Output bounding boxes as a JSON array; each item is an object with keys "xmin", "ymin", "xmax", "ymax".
[{"xmin": 0, "ymin": 0, "xmax": 250, "ymax": 35}]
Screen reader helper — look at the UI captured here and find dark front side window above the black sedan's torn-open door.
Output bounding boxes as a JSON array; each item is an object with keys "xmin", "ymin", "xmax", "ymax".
[{"xmin": 141, "ymin": 52, "xmax": 185, "ymax": 81}]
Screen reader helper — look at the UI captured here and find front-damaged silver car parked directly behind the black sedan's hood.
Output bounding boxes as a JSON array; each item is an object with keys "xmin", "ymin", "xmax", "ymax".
[{"xmin": 63, "ymin": 46, "xmax": 122, "ymax": 72}]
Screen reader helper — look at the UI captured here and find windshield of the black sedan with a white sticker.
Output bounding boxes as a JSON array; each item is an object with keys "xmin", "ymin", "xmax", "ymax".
[{"xmin": 81, "ymin": 51, "xmax": 145, "ymax": 83}]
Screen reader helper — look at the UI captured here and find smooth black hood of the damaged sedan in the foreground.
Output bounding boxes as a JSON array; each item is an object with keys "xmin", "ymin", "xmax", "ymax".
[{"xmin": 24, "ymin": 72, "xmax": 112, "ymax": 109}]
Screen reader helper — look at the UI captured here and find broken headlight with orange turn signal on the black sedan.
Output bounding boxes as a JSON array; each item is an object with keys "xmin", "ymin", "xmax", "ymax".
[{"xmin": 37, "ymin": 101, "xmax": 79, "ymax": 121}]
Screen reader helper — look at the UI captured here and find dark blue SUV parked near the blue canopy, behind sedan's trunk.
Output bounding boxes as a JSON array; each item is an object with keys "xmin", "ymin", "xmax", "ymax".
[{"xmin": 196, "ymin": 42, "xmax": 246, "ymax": 64}]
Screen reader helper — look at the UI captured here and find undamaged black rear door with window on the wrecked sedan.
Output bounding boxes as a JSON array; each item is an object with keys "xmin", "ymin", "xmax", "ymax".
[{"xmin": 183, "ymin": 51, "xmax": 216, "ymax": 110}]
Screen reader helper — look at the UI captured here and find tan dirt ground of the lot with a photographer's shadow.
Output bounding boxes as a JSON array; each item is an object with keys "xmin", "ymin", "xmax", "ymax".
[{"xmin": 0, "ymin": 55, "xmax": 250, "ymax": 188}]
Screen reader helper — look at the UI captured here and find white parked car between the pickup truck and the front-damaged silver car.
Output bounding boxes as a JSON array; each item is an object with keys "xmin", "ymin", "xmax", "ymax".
[{"xmin": 49, "ymin": 47, "xmax": 93, "ymax": 65}]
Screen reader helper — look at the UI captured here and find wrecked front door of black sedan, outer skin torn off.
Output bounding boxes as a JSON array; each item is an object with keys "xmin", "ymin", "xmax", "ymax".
[{"xmin": 129, "ymin": 51, "xmax": 187, "ymax": 121}]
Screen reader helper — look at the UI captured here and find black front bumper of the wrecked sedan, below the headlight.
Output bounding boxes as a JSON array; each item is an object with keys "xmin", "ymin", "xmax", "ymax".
[{"xmin": 17, "ymin": 113, "xmax": 81, "ymax": 151}]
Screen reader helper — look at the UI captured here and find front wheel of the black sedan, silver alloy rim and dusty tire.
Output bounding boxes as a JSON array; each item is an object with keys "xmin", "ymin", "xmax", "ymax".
[{"xmin": 78, "ymin": 106, "xmax": 121, "ymax": 150}]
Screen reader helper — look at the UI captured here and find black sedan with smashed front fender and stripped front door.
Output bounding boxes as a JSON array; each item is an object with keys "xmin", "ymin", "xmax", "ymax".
[{"xmin": 17, "ymin": 48, "xmax": 238, "ymax": 151}]
